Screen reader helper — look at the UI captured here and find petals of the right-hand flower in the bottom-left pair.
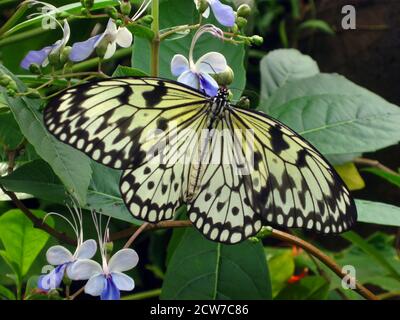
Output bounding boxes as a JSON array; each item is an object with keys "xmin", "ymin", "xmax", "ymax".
[{"xmin": 72, "ymin": 249, "xmax": 139, "ymax": 300}]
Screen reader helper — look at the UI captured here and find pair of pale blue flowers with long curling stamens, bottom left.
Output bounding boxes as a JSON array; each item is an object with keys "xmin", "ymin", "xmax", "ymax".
[{"xmin": 38, "ymin": 204, "xmax": 139, "ymax": 300}]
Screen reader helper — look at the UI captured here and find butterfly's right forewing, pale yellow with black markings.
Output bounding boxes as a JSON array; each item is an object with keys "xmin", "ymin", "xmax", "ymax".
[{"xmin": 230, "ymin": 107, "xmax": 357, "ymax": 233}]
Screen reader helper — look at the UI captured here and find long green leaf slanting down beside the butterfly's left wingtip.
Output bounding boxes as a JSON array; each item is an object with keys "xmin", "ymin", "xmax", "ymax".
[{"xmin": 0, "ymin": 66, "xmax": 92, "ymax": 204}]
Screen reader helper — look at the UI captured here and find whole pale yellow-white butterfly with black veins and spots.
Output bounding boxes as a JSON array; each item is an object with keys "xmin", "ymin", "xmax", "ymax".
[{"xmin": 43, "ymin": 77, "xmax": 357, "ymax": 244}]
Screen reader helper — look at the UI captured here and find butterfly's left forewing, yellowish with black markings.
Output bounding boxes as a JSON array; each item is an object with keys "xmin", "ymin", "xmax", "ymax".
[{"xmin": 44, "ymin": 78, "xmax": 207, "ymax": 169}]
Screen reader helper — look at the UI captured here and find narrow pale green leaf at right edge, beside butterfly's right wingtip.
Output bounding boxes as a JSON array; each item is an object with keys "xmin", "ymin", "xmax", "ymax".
[{"xmin": 356, "ymin": 199, "xmax": 400, "ymax": 227}]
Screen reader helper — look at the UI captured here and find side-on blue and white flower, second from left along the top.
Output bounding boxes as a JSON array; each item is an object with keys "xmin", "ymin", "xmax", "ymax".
[{"xmin": 69, "ymin": 19, "xmax": 132, "ymax": 62}]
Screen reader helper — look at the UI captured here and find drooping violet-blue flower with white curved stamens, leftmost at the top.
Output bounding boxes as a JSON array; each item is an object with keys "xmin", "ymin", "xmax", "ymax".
[{"xmin": 21, "ymin": 20, "xmax": 70, "ymax": 70}]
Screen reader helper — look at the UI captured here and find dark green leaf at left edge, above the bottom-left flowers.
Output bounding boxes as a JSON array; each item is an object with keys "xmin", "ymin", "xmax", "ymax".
[{"xmin": 0, "ymin": 160, "xmax": 66, "ymax": 203}]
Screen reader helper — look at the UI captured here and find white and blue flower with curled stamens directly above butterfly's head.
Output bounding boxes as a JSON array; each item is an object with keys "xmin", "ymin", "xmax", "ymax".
[{"xmin": 171, "ymin": 25, "xmax": 228, "ymax": 97}]
